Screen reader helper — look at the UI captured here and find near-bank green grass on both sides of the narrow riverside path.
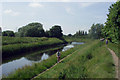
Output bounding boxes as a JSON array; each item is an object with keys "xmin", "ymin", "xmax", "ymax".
[{"xmin": 7, "ymin": 40, "xmax": 115, "ymax": 79}]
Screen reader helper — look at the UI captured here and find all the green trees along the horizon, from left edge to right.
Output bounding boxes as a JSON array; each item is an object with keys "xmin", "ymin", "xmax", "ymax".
[{"xmin": 2, "ymin": 1, "xmax": 120, "ymax": 43}]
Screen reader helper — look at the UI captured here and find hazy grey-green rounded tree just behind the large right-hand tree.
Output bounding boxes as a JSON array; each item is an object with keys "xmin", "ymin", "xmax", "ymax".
[{"xmin": 89, "ymin": 23, "xmax": 104, "ymax": 39}]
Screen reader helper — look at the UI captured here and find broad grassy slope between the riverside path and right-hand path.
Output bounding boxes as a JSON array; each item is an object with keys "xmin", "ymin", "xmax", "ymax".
[{"xmin": 37, "ymin": 41, "xmax": 115, "ymax": 79}]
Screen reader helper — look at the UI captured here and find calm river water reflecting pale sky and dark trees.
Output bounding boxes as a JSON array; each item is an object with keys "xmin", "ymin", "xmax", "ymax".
[{"xmin": 0, "ymin": 42, "xmax": 84, "ymax": 76}]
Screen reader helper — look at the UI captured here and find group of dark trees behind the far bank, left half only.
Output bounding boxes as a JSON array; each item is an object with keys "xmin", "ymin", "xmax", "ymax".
[{"xmin": 2, "ymin": 22, "xmax": 63, "ymax": 38}]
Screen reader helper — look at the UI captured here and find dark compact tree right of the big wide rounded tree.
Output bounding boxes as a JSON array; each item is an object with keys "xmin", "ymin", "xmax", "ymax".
[{"xmin": 49, "ymin": 25, "xmax": 63, "ymax": 38}]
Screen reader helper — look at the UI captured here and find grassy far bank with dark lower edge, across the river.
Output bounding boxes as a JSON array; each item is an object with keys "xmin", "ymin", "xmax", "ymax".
[{"xmin": 2, "ymin": 37, "xmax": 66, "ymax": 60}]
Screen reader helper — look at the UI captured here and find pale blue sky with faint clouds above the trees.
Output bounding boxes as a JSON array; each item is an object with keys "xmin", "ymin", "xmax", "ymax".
[{"xmin": 0, "ymin": 2, "xmax": 114, "ymax": 35}]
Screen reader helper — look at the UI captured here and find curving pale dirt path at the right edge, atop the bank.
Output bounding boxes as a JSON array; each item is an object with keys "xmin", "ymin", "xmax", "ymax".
[{"xmin": 108, "ymin": 48, "xmax": 120, "ymax": 80}]
